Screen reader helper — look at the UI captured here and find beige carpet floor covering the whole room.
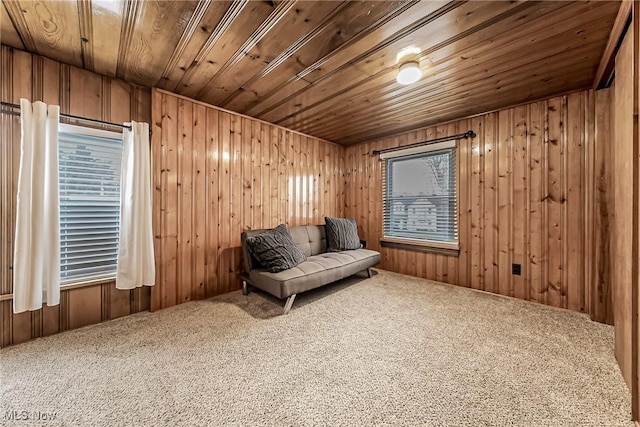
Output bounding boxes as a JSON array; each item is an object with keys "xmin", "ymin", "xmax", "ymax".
[{"xmin": 0, "ymin": 271, "xmax": 632, "ymax": 426}]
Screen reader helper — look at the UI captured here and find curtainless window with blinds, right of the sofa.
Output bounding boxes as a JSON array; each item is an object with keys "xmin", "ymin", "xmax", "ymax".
[{"xmin": 380, "ymin": 142, "xmax": 458, "ymax": 250}]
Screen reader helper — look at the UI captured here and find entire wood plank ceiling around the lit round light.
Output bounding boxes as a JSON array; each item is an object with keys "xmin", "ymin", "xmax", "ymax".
[{"xmin": 0, "ymin": 0, "xmax": 620, "ymax": 145}]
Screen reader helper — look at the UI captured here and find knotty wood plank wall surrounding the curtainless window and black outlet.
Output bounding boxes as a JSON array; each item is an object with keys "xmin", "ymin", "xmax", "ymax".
[{"xmin": 344, "ymin": 91, "xmax": 611, "ymax": 321}]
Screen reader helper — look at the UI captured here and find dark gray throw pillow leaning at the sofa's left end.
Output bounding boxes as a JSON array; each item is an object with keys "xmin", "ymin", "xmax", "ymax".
[{"xmin": 246, "ymin": 224, "xmax": 307, "ymax": 273}]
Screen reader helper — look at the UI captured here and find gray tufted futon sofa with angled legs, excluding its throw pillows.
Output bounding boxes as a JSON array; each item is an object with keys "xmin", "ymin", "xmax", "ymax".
[{"xmin": 239, "ymin": 225, "xmax": 380, "ymax": 314}]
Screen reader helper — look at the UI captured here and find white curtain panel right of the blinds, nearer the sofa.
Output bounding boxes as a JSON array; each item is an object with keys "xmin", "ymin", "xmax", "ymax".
[{"xmin": 116, "ymin": 121, "xmax": 156, "ymax": 289}]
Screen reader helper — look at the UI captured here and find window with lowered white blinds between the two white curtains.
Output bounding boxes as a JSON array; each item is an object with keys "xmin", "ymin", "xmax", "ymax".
[{"xmin": 58, "ymin": 125, "xmax": 122, "ymax": 285}]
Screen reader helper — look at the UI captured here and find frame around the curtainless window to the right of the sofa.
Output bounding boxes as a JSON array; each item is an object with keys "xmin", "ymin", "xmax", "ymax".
[{"xmin": 380, "ymin": 140, "xmax": 460, "ymax": 256}]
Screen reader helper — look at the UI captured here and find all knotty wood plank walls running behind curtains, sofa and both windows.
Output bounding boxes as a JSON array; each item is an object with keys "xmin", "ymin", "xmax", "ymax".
[{"xmin": 0, "ymin": 46, "xmax": 613, "ymax": 346}]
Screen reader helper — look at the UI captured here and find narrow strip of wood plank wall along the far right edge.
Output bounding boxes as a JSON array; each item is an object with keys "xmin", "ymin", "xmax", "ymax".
[{"xmin": 610, "ymin": 1, "xmax": 640, "ymax": 414}]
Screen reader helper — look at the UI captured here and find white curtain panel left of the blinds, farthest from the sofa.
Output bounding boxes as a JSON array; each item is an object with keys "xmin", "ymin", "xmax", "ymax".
[{"xmin": 13, "ymin": 99, "xmax": 60, "ymax": 313}]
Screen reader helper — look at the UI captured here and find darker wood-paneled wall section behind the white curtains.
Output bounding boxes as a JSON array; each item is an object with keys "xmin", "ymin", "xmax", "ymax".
[{"xmin": 0, "ymin": 46, "xmax": 151, "ymax": 347}]
